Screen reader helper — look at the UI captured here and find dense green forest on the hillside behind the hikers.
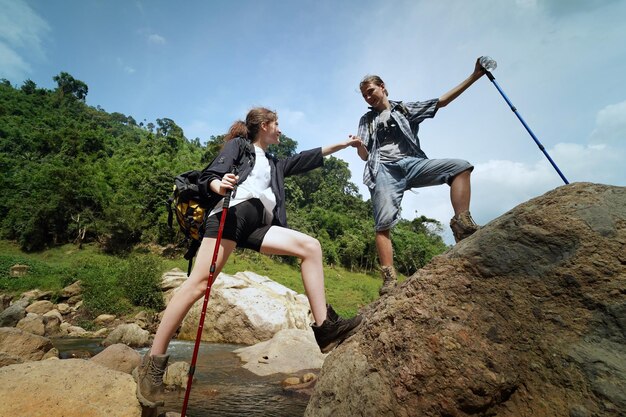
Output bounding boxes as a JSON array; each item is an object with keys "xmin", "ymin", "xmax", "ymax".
[{"xmin": 0, "ymin": 72, "xmax": 446, "ymax": 274}]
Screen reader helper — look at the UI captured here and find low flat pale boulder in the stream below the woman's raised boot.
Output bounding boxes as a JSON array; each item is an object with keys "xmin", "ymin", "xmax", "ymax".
[{"xmin": 235, "ymin": 329, "xmax": 326, "ymax": 376}]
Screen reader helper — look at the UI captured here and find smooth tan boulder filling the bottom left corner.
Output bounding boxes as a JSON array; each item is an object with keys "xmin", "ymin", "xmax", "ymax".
[{"xmin": 0, "ymin": 359, "xmax": 141, "ymax": 417}]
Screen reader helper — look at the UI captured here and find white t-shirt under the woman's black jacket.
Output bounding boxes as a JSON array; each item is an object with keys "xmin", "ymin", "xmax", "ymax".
[{"xmin": 210, "ymin": 145, "xmax": 276, "ymax": 224}]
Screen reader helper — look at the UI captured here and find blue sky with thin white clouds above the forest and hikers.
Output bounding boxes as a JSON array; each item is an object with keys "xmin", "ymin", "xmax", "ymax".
[{"xmin": 0, "ymin": 0, "xmax": 626, "ymax": 243}]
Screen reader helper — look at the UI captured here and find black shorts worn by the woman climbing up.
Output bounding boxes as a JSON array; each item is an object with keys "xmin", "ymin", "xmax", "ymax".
[{"xmin": 204, "ymin": 198, "xmax": 272, "ymax": 252}]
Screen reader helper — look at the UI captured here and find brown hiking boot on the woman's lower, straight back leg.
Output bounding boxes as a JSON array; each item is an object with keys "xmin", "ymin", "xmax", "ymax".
[{"xmin": 133, "ymin": 352, "xmax": 170, "ymax": 408}]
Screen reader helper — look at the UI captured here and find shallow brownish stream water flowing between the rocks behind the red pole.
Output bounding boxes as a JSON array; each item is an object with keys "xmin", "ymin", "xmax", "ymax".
[{"xmin": 53, "ymin": 339, "xmax": 308, "ymax": 417}]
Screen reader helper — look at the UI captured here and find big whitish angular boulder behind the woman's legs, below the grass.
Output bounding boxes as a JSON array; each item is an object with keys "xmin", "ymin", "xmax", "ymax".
[{"xmin": 178, "ymin": 272, "xmax": 310, "ymax": 345}]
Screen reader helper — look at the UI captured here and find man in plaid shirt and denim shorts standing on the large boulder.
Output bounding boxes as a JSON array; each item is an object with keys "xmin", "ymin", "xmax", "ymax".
[{"xmin": 348, "ymin": 60, "xmax": 485, "ymax": 295}]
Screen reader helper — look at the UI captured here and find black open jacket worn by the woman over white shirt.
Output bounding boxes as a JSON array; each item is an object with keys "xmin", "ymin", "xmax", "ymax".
[{"xmin": 198, "ymin": 138, "xmax": 324, "ymax": 227}]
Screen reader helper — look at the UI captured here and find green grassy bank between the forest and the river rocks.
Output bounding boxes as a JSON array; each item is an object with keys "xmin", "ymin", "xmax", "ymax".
[{"xmin": 0, "ymin": 241, "xmax": 381, "ymax": 317}]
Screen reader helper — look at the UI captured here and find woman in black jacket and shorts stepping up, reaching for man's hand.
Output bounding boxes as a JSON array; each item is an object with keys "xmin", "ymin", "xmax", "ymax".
[{"xmin": 133, "ymin": 108, "xmax": 362, "ymax": 407}]
